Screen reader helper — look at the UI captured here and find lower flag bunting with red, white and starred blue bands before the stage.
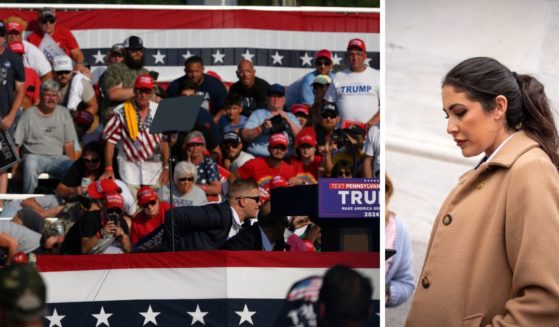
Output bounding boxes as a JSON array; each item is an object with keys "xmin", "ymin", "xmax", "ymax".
[{"xmin": 37, "ymin": 251, "xmax": 379, "ymax": 327}]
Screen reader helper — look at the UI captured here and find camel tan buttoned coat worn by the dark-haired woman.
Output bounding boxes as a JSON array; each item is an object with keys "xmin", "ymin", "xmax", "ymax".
[{"xmin": 406, "ymin": 131, "xmax": 559, "ymax": 327}]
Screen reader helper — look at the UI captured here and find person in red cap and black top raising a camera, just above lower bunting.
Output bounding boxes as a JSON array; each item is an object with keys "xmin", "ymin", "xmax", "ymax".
[{"xmin": 61, "ymin": 179, "xmax": 131, "ymax": 254}]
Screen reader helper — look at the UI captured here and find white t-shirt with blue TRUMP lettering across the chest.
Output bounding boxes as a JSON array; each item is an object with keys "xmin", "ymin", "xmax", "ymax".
[{"xmin": 324, "ymin": 67, "xmax": 380, "ymax": 123}]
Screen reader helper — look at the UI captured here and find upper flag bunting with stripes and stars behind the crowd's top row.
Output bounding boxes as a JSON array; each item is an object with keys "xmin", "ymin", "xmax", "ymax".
[{"xmin": 0, "ymin": 6, "xmax": 380, "ymax": 85}]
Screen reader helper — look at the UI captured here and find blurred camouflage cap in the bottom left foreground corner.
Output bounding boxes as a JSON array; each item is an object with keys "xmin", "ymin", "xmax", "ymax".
[{"xmin": 0, "ymin": 264, "xmax": 47, "ymax": 323}]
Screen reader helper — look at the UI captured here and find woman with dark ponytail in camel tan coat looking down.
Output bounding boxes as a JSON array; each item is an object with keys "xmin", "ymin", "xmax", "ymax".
[{"xmin": 406, "ymin": 57, "xmax": 559, "ymax": 327}]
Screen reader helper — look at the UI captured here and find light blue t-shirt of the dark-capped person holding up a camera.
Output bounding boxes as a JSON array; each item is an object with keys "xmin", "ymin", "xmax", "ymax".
[{"xmin": 245, "ymin": 109, "xmax": 301, "ymax": 157}]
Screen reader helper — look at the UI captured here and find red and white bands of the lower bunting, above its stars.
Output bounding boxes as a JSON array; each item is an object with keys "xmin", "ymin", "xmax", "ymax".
[{"xmin": 37, "ymin": 251, "xmax": 380, "ymax": 303}]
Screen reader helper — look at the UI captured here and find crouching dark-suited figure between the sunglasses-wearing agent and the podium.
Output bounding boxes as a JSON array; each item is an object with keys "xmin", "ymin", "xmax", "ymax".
[{"xmin": 221, "ymin": 201, "xmax": 288, "ymax": 251}]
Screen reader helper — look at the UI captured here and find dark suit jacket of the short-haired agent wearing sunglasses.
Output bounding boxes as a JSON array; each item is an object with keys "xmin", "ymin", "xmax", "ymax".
[{"xmin": 161, "ymin": 202, "xmax": 233, "ymax": 251}]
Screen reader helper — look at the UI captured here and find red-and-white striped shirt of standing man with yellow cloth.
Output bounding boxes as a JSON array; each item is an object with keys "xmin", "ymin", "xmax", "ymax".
[{"xmin": 103, "ymin": 102, "xmax": 161, "ymax": 162}]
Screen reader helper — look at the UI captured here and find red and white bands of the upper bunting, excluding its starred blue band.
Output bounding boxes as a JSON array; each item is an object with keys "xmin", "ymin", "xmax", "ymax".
[{"xmin": 0, "ymin": 5, "xmax": 381, "ymax": 85}]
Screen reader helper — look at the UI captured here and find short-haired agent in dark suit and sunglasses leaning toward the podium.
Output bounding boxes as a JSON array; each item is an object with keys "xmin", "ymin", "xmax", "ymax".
[{"xmin": 161, "ymin": 179, "xmax": 260, "ymax": 251}]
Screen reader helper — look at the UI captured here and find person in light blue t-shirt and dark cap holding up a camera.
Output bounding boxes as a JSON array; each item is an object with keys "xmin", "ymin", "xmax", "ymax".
[{"xmin": 241, "ymin": 84, "xmax": 301, "ymax": 157}]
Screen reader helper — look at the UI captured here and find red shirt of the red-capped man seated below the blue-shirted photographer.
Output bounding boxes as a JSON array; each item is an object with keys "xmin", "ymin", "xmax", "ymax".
[{"xmin": 237, "ymin": 157, "xmax": 295, "ymax": 196}]
